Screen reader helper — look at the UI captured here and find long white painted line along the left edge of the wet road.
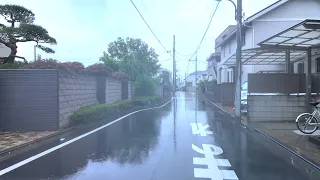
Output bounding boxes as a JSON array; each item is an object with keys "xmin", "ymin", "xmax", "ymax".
[{"xmin": 0, "ymin": 97, "xmax": 173, "ymax": 176}]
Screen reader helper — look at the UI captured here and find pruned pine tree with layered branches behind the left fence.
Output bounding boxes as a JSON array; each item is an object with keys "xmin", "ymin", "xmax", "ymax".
[{"xmin": 0, "ymin": 4, "xmax": 57, "ymax": 63}]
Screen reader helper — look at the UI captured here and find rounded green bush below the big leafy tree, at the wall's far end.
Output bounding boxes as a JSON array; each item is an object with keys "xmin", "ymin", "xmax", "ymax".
[{"xmin": 135, "ymin": 76, "xmax": 158, "ymax": 96}]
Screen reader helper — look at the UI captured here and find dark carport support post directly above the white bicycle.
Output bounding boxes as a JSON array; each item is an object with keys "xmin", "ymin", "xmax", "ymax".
[{"xmin": 306, "ymin": 48, "xmax": 311, "ymax": 112}]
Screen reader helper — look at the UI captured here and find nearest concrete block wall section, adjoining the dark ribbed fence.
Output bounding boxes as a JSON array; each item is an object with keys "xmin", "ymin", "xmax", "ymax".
[{"xmin": 59, "ymin": 73, "xmax": 98, "ymax": 127}]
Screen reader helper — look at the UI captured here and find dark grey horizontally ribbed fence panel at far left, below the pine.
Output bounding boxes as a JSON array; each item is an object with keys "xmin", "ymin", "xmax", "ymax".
[{"xmin": 0, "ymin": 70, "xmax": 59, "ymax": 131}]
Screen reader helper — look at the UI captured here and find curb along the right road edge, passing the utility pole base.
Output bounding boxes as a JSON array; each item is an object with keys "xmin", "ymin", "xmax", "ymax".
[{"xmin": 204, "ymin": 97, "xmax": 320, "ymax": 171}]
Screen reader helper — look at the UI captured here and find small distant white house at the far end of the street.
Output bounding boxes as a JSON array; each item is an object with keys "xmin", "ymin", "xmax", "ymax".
[{"xmin": 186, "ymin": 71, "xmax": 208, "ymax": 92}]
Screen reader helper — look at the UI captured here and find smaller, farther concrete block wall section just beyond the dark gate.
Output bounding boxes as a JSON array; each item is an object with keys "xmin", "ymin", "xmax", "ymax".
[{"xmin": 106, "ymin": 78, "xmax": 122, "ymax": 104}]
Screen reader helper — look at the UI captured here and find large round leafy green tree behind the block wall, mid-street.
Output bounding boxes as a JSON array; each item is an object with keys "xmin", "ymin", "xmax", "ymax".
[{"xmin": 100, "ymin": 37, "xmax": 160, "ymax": 80}]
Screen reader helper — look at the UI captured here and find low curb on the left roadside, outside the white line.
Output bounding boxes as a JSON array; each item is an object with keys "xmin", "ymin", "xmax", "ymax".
[{"xmin": 0, "ymin": 96, "xmax": 172, "ymax": 156}]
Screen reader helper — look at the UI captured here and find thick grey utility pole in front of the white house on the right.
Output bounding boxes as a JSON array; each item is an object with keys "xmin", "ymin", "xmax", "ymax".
[{"xmin": 235, "ymin": 0, "xmax": 242, "ymax": 118}]
